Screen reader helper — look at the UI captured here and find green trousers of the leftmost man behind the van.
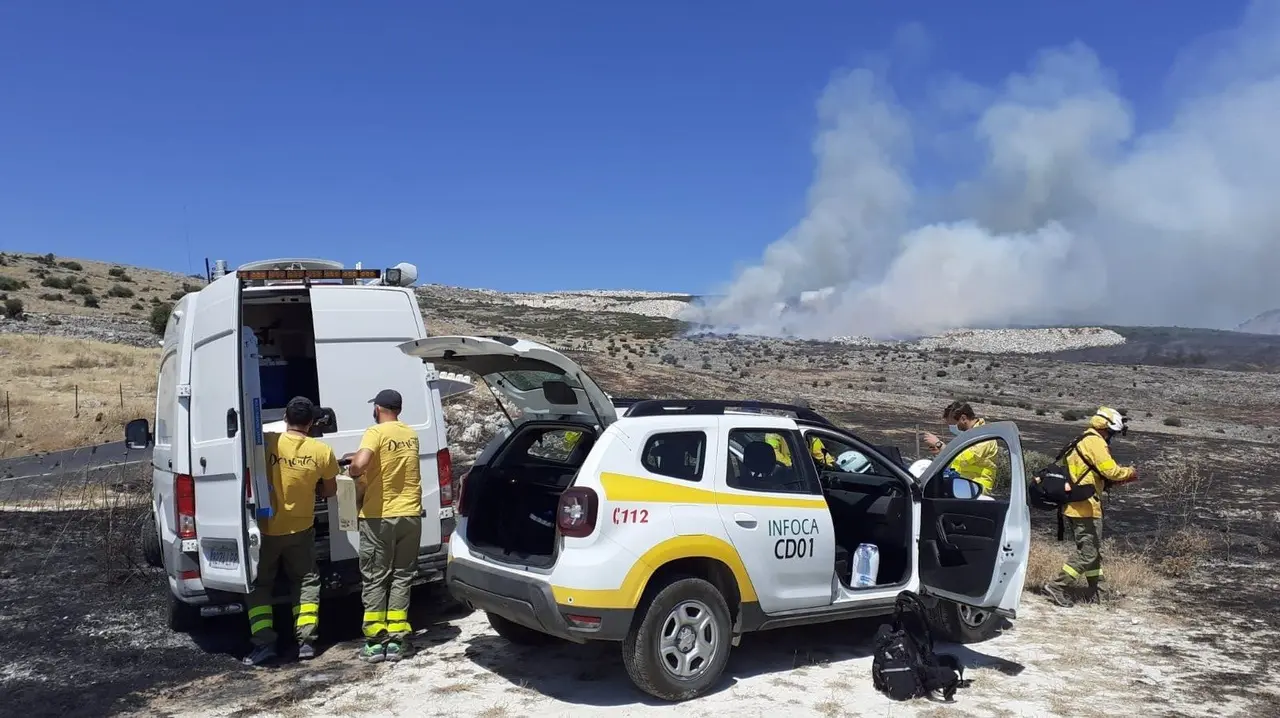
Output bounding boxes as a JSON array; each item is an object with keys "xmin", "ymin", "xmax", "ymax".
[{"xmin": 248, "ymin": 529, "xmax": 320, "ymax": 645}]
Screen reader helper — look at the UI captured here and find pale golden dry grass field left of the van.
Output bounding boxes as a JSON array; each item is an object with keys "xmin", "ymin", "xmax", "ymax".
[{"xmin": 0, "ymin": 334, "xmax": 160, "ymax": 457}]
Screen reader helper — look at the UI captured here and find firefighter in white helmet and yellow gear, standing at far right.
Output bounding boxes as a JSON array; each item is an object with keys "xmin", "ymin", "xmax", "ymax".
[{"xmin": 1044, "ymin": 407, "xmax": 1138, "ymax": 608}]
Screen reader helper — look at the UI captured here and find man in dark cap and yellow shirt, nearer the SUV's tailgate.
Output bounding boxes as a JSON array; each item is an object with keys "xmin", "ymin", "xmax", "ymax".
[{"xmin": 348, "ymin": 389, "xmax": 422, "ymax": 663}]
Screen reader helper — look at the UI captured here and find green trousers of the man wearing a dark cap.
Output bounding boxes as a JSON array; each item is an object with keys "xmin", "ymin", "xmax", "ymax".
[{"xmin": 360, "ymin": 516, "xmax": 422, "ymax": 644}]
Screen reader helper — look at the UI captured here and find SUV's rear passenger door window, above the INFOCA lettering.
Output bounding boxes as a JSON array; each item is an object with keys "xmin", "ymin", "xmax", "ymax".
[{"xmin": 726, "ymin": 429, "xmax": 822, "ymax": 494}]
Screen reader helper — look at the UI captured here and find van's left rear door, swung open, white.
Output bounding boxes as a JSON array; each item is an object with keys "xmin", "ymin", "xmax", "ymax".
[{"xmin": 191, "ymin": 273, "xmax": 252, "ymax": 594}]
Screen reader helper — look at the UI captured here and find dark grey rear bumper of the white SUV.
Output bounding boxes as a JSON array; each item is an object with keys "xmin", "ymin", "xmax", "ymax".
[{"xmin": 445, "ymin": 558, "xmax": 634, "ymax": 644}]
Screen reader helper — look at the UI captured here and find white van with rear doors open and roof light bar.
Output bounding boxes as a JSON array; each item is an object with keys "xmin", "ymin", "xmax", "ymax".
[{"xmin": 125, "ymin": 260, "xmax": 461, "ymax": 630}]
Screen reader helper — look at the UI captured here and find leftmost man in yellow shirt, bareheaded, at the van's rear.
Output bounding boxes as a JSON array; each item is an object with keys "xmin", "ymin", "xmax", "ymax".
[{"xmin": 244, "ymin": 397, "xmax": 338, "ymax": 666}]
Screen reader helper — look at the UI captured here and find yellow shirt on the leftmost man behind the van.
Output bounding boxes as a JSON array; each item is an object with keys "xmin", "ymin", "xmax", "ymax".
[{"xmin": 262, "ymin": 433, "xmax": 338, "ymax": 536}]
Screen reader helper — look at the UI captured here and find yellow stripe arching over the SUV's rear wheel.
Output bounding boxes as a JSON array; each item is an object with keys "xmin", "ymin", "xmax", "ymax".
[{"xmin": 552, "ymin": 534, "xmax": 759, "ymax": 608}]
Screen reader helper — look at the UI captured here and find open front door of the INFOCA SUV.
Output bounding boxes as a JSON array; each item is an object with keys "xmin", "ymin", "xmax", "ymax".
[{"xmin": 919, "ymin": 421, "xmax": 1030, "ymax": 617}]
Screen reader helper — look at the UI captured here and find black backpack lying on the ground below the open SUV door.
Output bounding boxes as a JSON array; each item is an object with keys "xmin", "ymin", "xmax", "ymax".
[{"xmin": 872, "ymin": 591, "xmax": 970, "ymax": 701}]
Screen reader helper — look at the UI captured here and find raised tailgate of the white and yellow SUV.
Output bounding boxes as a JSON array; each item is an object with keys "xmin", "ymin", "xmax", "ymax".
[{"xmin": 399, "ymin": 337, "xmax": 618, "ymax": 429}]
